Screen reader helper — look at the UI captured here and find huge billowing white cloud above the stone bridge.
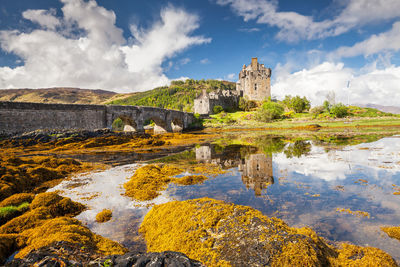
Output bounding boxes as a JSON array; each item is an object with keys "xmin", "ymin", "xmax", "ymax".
[{"xmin": 0, "ymin": 0, "xmax": 211, "ymax": 92}]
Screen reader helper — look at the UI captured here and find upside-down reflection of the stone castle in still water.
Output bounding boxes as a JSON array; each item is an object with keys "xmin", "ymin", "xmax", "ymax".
[{"xmin": 196, "ymin": 145, "xmax": 274, "ymax": 196}]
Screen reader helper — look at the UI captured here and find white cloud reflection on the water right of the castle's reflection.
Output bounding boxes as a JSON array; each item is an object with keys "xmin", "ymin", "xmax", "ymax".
[{"xmin": 274, "ymin": 137, "xmax": 400, "ymax": 181}]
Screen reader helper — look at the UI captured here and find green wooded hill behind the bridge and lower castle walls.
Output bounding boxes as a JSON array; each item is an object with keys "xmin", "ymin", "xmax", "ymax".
[{"xmin": 107, "ymin": 79, "xmax": 236, "ymax": 112}]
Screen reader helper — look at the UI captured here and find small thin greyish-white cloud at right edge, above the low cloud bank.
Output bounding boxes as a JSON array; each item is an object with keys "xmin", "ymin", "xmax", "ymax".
[{"xmin": 332, "ymin": 21, "xmax": 400, "ymax": 57}]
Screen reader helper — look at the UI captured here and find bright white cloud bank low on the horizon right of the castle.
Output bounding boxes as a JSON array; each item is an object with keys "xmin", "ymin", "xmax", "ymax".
[{"xmin": 271, "ymin": 62, "xmax": 400, "ymax": 106}]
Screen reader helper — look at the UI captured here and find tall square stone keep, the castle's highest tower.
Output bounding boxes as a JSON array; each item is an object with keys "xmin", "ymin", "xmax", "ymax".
[{"xmin": 236, "ymin": 57, "xmax": 271, "ymax": 101}]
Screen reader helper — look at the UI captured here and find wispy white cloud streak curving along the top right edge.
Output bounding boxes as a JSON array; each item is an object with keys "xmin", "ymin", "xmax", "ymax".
[{"xmin": 216, "ymin": 0, "xmax": 400, "ymax": 42}]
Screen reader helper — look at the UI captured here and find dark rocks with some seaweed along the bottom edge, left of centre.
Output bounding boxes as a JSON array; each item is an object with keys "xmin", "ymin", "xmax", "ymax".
[{"xmin": 6, "ymin": 241, "xmax": 204, "ymax": 267}]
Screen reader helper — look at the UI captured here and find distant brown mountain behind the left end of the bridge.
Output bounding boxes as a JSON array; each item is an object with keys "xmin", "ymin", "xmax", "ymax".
[{"xmin": 0, "ymin": 87, "xmax": 117, "ymax": 104}]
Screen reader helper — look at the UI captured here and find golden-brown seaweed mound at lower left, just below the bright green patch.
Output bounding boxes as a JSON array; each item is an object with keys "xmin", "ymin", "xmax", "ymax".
[{"xmin": 0, "ymin": 193, "xmax": 97, "ymax": 263}]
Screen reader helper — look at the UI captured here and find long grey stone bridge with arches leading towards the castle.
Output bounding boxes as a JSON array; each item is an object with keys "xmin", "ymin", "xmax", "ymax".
[{"xmin": 0, "ymin": 102, "xmax": 194, "ymax": 135}]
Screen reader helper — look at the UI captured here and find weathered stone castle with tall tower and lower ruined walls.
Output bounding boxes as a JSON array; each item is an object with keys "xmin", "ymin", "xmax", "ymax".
[{"xmin": 194, "ymin": 57, "xmax": 271, "ymax": 115}]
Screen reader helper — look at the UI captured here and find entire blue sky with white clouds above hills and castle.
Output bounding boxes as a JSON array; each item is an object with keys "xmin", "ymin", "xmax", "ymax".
[{"xmin": 0, "ymin": 0, "xmax": 400, "ymax": 106}]
